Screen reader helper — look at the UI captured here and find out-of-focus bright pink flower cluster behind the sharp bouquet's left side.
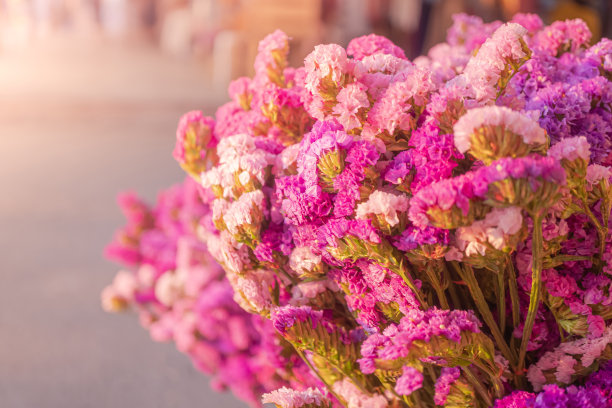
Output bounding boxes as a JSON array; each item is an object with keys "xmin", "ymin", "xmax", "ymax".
[{"xmin": 102, "ymin": 178, "xmax": 313, "ymax": 406}]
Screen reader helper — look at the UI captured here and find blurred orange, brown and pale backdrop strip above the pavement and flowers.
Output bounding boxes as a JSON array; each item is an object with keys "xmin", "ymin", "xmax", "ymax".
[{"xmin": 0, "ymin": 0, "xmax": 612, "ymax": 75}]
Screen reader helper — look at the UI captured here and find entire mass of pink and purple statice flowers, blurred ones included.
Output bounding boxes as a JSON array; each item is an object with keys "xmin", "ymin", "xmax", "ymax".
[{"xmin": 103, "ymin": 14, "xmax": 612, "ymax": 408}]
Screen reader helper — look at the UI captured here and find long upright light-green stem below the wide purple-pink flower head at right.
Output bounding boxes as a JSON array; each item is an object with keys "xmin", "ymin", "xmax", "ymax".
[{"xmin": 516, "ymin": 213, "xmax": 544, "ymax": 376}]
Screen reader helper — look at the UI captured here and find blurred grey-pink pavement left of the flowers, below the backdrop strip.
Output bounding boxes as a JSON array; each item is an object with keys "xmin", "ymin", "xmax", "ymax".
[{"xmin": 0, "ymin": 41, "xmax": 244, "ymax": 408}]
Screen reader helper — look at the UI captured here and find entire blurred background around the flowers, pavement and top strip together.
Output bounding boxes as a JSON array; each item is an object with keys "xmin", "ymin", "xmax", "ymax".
[{"xmin": 0, "ymin": 0, "xmax": 612, "ymax": 408}]
